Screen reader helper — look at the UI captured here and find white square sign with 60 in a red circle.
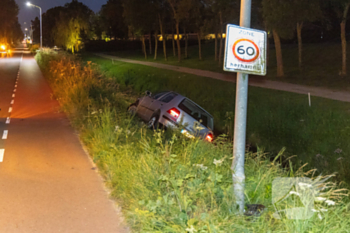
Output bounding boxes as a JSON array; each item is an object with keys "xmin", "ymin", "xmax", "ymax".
[{"xmin": 224, "ymin": 24, "xmax": 267, "ymax": 75}]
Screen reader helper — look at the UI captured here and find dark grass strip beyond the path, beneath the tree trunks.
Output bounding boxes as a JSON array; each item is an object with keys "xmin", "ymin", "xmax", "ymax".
[{"xmin": 106, "ymin": 43, "xmax": 350, "ymax": 90}]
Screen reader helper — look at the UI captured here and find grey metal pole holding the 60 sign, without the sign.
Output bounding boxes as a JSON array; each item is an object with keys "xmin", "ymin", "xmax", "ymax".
[{"xmin": 231, "ymin": 0, "xmax": 251, "ymax": 213}]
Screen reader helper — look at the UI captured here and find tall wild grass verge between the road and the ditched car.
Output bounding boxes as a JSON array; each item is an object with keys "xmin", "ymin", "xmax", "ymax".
[{"xmin": 37, "ymin": 53, "xmax": 350, "ymax": 232}]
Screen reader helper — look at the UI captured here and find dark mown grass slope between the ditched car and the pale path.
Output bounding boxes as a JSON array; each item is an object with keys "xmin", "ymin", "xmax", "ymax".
[{"xmin": 84, "ymin": 53, "xmax": 350, "ymax": 180}]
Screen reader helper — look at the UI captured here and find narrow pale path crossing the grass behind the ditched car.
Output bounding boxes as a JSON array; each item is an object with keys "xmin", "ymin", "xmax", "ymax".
[{"xmin": 93, "ymin": 53, "xmax": 350, "ymax": 102}]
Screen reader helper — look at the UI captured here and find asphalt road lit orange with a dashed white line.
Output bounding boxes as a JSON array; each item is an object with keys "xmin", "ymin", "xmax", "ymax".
[{"xmin": 0, "ymin": 48, "xmax": 128, "ymax": 233}]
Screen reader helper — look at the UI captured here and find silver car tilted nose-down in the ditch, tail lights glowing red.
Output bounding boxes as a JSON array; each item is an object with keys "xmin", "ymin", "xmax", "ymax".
[{"xmin": 128, "ymin": 91, "xmax": 214, "ymax": 142}]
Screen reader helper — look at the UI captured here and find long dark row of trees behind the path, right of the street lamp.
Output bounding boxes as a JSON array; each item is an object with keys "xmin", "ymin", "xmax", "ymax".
[{"xmin": 33, "ymin": 0, "xmax": 350, "ymax": 76}]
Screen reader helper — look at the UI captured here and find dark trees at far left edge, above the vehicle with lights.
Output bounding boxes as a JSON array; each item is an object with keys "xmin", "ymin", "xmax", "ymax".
[{"xmin": 0, "ymin": 0, "xmax": 24, "ymax": 44}]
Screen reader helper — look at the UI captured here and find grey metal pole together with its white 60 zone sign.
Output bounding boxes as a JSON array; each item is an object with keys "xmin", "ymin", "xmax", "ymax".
[{"xmin": 224, "ymin": 0, "xmax": 267, "ymax": 214}]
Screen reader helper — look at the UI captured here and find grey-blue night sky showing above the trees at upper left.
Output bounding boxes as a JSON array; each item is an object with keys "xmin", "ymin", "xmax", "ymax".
[{"xmin": 16, "ymin": 0, "xmax": 107, "ymax": 31}]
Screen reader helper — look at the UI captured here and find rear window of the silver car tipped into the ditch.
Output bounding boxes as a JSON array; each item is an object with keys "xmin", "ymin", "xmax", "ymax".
[{"xmin": 179, "ymin": 99, "xmax": 214, "ymax": 130}]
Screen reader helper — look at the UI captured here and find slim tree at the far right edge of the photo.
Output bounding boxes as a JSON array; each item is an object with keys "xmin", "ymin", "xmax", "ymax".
[{"xmin": 330, "ymin": 0, "xmax": 350, "ymax": 76}]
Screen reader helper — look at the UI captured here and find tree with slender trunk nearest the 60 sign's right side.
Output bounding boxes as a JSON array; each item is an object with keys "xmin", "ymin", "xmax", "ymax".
[{"xmin": 262, "ymin": 0, "xmax": 295, "ymax": 77}]
